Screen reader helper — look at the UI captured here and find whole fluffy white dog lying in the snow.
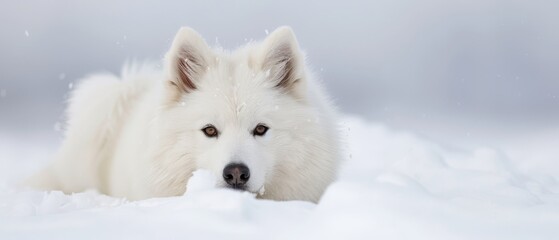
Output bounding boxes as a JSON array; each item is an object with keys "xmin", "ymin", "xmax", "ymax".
[{"xmin": 29, "ymin": 27, "xmax": 339, "ymax": 202}]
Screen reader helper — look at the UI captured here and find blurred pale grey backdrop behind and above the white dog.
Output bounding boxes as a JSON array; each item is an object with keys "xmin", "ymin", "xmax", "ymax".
[{"xmin": 0, "ymin": 0, "xmax": 559, "ymax": 142}]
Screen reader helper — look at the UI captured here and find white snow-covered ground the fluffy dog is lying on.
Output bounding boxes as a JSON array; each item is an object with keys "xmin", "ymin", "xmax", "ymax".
[{"xmin": 0, "ymin": 117, "xmax": 559, "ymax": 239}]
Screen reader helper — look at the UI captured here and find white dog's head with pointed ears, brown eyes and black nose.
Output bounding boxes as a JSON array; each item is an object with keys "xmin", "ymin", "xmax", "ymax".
[{"xmin": 155, "ymin": 27, "xmax": 326, "ymax": 196}]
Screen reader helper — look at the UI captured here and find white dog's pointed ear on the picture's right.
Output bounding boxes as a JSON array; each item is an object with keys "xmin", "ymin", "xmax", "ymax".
[{"xmin": 260, "ymin": 27, "xmax": 304, "ymax": 93}]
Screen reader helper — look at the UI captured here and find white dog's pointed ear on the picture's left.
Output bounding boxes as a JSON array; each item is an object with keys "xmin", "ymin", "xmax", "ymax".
[{"xmin": 165, "ymin": 27, "xmax": 212, "ymax": 92}]
